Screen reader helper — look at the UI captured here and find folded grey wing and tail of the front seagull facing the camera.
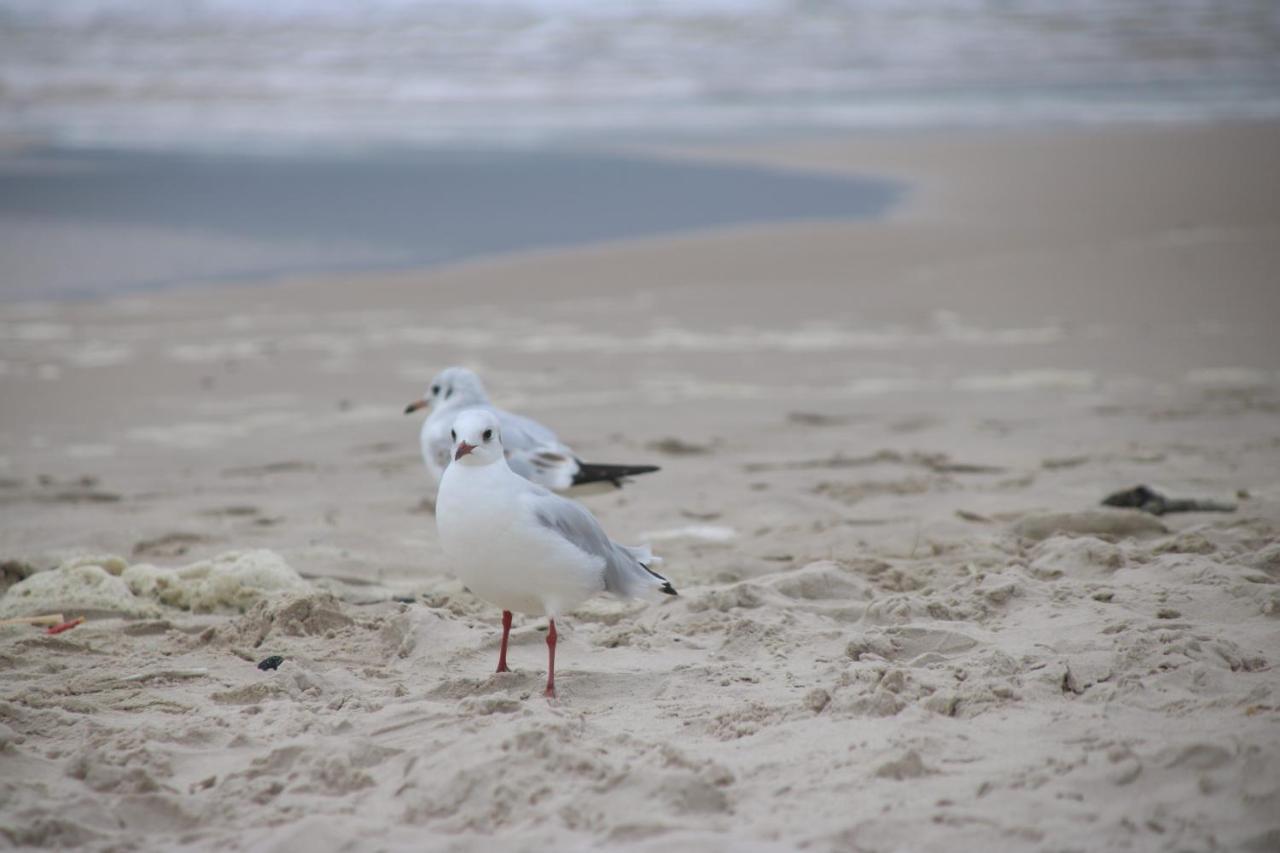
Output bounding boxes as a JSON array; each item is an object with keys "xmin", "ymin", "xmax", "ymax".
[{"xmin": 529, "ymin": 489, "xmax": 676, "ymax": 598}]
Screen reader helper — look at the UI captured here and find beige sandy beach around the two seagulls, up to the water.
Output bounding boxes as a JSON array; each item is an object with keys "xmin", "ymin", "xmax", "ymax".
[{"xmin": 0, "ymin": 127, "xmax": 1280, "ymax": 852}]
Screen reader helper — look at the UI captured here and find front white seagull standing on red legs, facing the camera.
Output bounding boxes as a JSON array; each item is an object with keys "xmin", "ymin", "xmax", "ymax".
[{"xmin": 435, "ymin": 409, "xmax": 676, "ymax": 697}]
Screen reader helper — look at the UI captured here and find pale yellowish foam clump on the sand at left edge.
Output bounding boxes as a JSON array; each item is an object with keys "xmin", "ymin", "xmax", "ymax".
[{"xmin": 0, "ymin": 549, "xmax": 310, "ymax": 619}]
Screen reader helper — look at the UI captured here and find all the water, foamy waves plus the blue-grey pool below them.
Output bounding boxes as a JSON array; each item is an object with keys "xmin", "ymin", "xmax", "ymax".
[{"xmin": 0, "ymin": 0, "xmax": 1280, "ymax": 301}]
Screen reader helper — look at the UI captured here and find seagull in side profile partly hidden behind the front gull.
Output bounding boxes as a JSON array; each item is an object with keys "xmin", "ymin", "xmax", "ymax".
[{"xmin": 404, "ymin": 368, "xmax": 658, "ymax": 492}]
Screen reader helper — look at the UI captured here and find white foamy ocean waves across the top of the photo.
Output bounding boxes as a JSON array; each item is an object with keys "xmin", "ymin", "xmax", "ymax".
[{"xmin": 0, "ymin": 0, "xmax": 1280, "ymax": 147}]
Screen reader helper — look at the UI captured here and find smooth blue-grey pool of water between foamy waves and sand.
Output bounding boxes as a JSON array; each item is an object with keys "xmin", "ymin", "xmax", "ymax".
[{"xmin": 0, "ymin": 146, "xmax": 902, "ymax": 300}]
